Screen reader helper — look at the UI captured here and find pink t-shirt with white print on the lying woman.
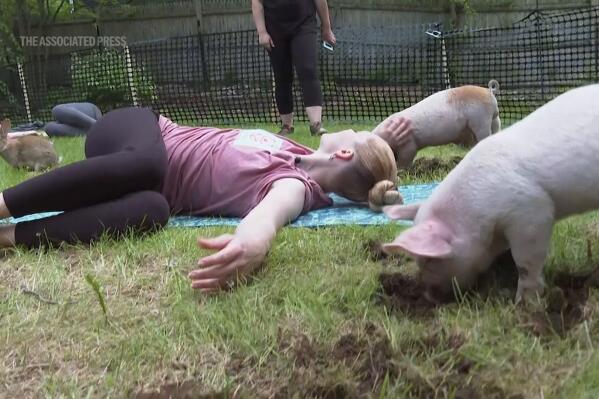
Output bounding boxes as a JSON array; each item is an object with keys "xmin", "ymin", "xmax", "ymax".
[{"xmin": 158, "ymin": 116, "xmax": 332, "ymax": 217}]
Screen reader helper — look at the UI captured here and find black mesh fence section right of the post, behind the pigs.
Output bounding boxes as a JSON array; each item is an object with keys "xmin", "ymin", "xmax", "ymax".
[{"xmin": 444, "ymin": 8, "xmax": 599, "ymax": 121}]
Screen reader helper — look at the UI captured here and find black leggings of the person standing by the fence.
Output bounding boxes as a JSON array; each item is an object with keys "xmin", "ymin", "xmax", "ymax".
[{"xmin": 268, "ymin": 19, "xmax": 322, "ymax": 115}]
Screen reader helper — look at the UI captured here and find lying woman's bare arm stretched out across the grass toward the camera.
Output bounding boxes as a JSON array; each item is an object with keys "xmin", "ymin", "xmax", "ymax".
[{"xmin": 189, "ymin": 178, "xmax": 306, "ymax": 292}]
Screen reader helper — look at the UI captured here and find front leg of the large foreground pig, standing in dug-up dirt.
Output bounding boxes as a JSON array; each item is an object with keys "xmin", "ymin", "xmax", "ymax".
[{"xmin": 506, "ymin": 216, "xmax": 553, "ymax": 303}]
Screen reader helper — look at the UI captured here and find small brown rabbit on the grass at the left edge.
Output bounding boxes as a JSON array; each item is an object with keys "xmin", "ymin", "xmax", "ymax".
[{"xmin": 0, "ymin": 119, "xmax": 59, "ymax": 172}]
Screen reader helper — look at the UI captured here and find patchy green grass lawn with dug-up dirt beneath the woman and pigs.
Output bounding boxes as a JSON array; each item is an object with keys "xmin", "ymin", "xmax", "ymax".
[{"xmin": 0, "ymin": 125, "xmax": 599, "ymax": 398}]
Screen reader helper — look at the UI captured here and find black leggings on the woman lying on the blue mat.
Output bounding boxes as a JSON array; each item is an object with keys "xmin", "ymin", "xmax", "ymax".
[{"xmin": 4, "ymin": 108, "xmax": 169, "ymax": 248}]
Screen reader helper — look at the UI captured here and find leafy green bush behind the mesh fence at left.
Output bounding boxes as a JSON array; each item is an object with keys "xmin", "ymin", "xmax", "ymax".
[{"xmin": 71, "ymin": 50, "xmax": 156, "ymax": 110}]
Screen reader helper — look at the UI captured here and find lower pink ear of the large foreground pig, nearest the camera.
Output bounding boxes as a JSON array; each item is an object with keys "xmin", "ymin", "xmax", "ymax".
[{"xmin": 382, "ymin": 221, "xmax": 453, "ymax": 259}]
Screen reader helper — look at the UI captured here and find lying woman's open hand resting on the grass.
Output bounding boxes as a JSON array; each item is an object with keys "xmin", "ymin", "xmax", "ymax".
[{"xmin": 188, "ymin": 234, "xmax": 268, "ymax": 293}]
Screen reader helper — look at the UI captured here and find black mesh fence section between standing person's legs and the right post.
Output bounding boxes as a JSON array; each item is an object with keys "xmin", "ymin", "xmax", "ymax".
[{"xmin": 322, "ymin": 25, "xmax": 443, "ymax": 120}]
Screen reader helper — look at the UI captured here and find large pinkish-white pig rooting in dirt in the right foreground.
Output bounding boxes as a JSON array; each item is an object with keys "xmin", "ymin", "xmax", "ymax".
[{"xmin": 383, "ymin": 84, "xmax": 599, "ymax": 302}]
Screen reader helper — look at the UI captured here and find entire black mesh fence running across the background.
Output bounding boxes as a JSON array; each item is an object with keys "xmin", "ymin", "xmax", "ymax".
[{"xmin": 0, "ymin": 8, "xmax": 599, "ymax": 124}]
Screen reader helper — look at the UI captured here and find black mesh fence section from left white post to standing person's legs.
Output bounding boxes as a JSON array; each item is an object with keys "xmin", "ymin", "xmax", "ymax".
[{"xmin": 130, "ymin": 31, "xmax": 274, "ymax": 123}]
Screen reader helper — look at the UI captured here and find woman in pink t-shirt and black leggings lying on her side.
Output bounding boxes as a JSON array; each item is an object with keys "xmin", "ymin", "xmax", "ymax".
[{"xmin": 0, "ymin": 108, "xmax": 410, "ymax": 291}]
